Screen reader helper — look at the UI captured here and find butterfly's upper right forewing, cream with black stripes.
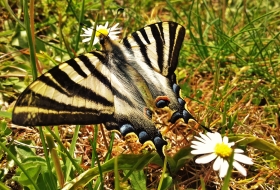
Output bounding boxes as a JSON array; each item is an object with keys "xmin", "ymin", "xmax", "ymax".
[{"xmin": 122, "ymin": 22, "xmax": 185, "ymax": 77}]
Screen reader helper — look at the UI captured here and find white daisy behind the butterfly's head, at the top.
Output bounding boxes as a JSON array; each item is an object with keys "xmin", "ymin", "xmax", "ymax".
[{"xmin": 81, "ymin": 21, "xmax": 122, "ymax": 45}]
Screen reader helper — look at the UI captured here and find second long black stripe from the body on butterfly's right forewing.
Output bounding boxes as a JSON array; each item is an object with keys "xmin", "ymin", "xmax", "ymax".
[{"xmin": 150, "ymin": 24, "xmax": 165, "ymax": 73}]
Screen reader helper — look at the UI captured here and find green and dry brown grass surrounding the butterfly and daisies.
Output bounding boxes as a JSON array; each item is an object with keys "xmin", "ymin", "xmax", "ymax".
[{"xmin": 0, "ymin": 0, "xmax": 280, "ymax": 189}]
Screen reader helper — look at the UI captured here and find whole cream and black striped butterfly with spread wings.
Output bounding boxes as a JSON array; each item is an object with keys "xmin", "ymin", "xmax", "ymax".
[{"xmin": 12, "ymin": 22, "xmax": 197, "ymax": 168}]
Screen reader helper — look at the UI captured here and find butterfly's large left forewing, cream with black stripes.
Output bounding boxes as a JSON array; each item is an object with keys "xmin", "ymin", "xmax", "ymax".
[{"xmin": 12, "ymin": 51, "xmax": 114, "ymax": 126}]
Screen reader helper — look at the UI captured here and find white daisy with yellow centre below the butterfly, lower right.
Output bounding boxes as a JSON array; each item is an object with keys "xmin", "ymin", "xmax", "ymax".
[{"xmin": 191, "ymin": 132, "xmax": 253, "ymax": 177}]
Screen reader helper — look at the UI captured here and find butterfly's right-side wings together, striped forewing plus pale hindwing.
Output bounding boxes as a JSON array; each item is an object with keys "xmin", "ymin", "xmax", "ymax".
[{"xmin": 122, "ymin": 22, "xmax": 193, "ymax": 123}]
